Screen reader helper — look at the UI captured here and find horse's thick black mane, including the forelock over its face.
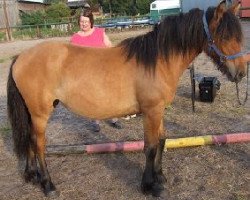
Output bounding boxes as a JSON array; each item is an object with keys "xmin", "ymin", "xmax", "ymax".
[{"xmin": 119, "ymin": 7, "xmax": 242, "ymax": 69}]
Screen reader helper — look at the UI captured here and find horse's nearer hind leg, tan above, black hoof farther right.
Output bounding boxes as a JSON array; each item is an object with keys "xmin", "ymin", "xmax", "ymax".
[{"xmin": 32, "ymin": 115, "xmax": 57, "ymax": 196}]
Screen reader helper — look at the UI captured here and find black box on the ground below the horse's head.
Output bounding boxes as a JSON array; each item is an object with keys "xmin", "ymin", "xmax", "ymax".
[{"xmin": 199, "ymin": 77, "xmax": 220, "ymax": 102}]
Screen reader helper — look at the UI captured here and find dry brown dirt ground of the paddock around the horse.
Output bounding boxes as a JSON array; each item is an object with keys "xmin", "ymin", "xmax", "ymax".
[{"xmin": 0, "ymin": 22, "xmax": 250, "ymax": 200}]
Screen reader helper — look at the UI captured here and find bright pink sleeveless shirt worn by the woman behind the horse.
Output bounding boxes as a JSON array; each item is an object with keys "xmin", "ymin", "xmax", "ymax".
[{"xmin": 70, "ymin": 27, "xmax": 106, "ymax": 47}]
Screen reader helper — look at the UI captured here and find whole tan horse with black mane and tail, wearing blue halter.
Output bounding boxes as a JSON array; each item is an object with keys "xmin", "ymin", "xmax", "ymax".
[{"xmin": 7, "ymin": 1, "xmax": 247, "ymax": 197}]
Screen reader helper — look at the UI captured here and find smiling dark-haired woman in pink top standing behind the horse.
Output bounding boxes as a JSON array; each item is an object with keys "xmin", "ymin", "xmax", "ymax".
[{"xmin": 70, "ymin": 9, "xmax": 122, "ymax": 132}]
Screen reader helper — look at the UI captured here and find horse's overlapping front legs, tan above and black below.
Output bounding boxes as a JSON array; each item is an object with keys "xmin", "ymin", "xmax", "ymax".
[{"xmin": 141, "ymin": 107, "xmax": 166, "ymax": 196}]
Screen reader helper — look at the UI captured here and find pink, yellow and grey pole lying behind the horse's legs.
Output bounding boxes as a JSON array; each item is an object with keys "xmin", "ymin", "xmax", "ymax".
[{"xmin": 46, "ymin": 132, "xmax": 250, "ymax": 155}]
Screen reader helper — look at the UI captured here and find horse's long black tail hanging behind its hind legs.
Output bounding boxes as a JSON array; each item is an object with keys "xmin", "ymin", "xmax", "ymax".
[{"xmin": 7, "ymin": 57, "xmax": 31, "ymax": 158}]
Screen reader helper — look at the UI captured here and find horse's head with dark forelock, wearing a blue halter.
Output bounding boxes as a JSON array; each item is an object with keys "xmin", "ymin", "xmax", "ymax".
[{"xmin": 203, "ymin": 1, "xmax": 247, "ymax": 82}]
